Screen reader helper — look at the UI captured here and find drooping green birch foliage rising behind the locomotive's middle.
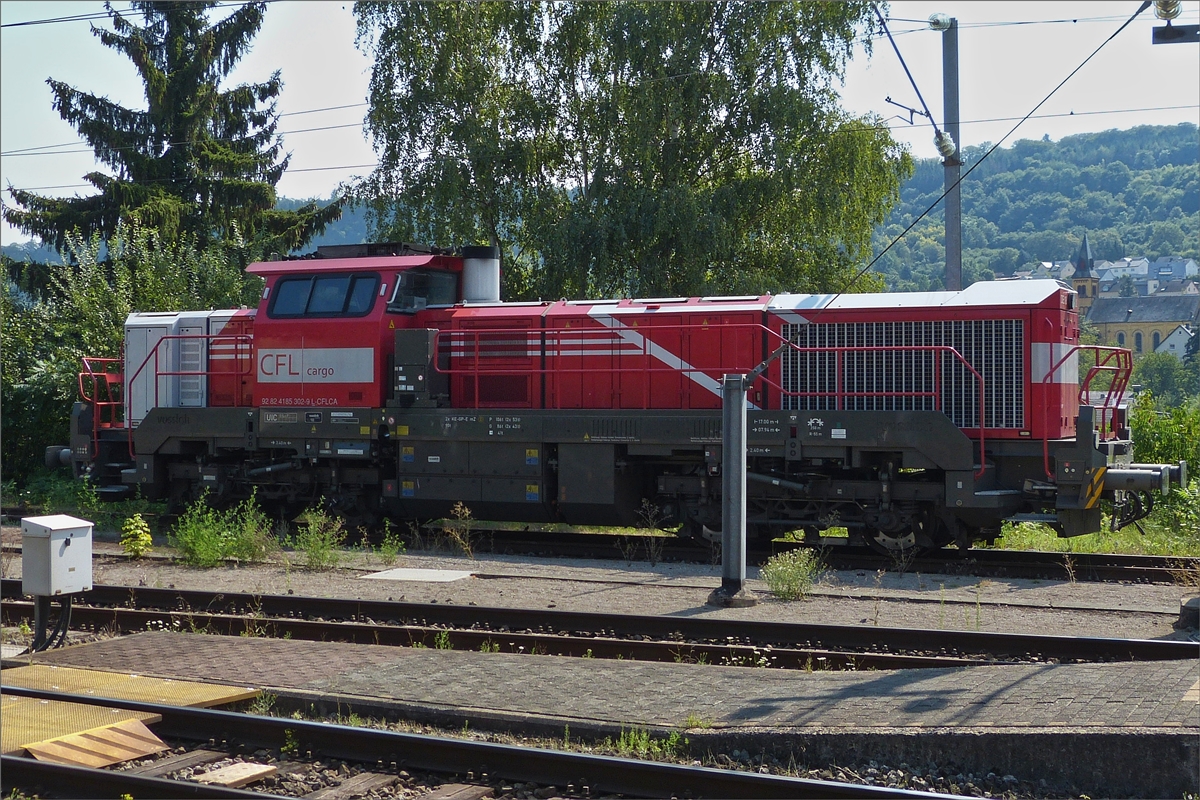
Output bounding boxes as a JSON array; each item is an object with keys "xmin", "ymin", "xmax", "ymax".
[{"xmin": 352, "ymin": 2, "xmax": 911, "ymax": 299}]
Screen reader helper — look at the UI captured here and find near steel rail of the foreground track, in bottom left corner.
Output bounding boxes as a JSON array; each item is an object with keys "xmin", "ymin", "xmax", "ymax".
[{"xmin": 0, "ymin": 753, "xmax": 274, "ymax": 800}]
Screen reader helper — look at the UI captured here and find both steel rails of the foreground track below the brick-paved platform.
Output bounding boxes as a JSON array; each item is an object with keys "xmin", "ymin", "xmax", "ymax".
[{"xmin": 0, "ymin": 686, "xmax": 947, "ymax": 799}]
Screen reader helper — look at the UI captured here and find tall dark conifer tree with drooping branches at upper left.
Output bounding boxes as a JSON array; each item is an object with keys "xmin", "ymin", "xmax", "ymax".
[{"xmin": 4, "ymin": 0, "xmax": 341, "ymax": 252}]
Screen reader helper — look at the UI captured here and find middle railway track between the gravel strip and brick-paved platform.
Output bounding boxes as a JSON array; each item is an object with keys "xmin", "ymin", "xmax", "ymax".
[{"xmin": 7, "ymin": 579, "xmax": 1200, "ymax": 669}]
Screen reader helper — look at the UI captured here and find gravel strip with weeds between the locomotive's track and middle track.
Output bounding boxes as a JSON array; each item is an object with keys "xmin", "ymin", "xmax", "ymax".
[{"xmin": 2, "ymin": 525, "xmax": 1195, "ymax": 638}]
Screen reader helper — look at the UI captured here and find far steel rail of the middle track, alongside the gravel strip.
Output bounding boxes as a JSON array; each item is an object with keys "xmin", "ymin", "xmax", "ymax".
[{"xmin": 7, "ymin": 578, "xmax": 1200, "ymax": 661}]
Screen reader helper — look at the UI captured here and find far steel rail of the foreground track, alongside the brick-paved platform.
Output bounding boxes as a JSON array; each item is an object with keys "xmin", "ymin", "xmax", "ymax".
[{"xmin": 0, "ymin": 685, "xmax": 947, "ymax": 800}]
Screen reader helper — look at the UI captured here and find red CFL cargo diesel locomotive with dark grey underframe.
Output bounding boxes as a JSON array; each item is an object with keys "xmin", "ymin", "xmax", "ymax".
[{"xmin": 56, "ymin": 245, "xmax": 1186, "ymax": 551}]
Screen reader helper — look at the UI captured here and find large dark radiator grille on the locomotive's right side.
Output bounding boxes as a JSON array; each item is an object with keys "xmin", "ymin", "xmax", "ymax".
[{"xmin": 782, "ymin": 319, "xmax": 1025, "ymax": 428}]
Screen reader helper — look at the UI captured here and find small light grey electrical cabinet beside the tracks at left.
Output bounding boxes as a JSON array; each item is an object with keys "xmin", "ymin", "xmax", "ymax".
[{"xmin": 20, "ymin": 513, "xmax": 91, "ymax": 596}]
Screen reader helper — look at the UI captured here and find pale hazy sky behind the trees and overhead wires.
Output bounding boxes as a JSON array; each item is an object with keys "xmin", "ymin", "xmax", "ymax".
[{"xmin": 0, "ymin": 0, "xmax": 1200, "ymax": 245}]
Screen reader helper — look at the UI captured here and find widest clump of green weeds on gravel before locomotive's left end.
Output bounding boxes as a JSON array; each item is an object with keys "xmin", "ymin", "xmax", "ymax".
[{"xmin": 167, "ymin": 495, "xmax": 272, "ymax": 567}]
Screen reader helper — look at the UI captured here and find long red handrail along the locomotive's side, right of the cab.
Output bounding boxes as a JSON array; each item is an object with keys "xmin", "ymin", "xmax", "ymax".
[{"xmin": 433, "ymin": 323, "xmax": 988, "ymax": 477}]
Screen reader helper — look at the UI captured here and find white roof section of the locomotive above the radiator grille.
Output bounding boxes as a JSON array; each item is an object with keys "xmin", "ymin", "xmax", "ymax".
[{"xmin": 768, "ymin": 279, "xmax": 1066, "ymax": 311}]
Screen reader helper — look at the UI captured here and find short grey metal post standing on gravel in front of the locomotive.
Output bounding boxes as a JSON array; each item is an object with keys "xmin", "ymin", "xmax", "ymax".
[{"xmin": 708, "ymin": 374, "xmax": 757, "ymax": 607}]
